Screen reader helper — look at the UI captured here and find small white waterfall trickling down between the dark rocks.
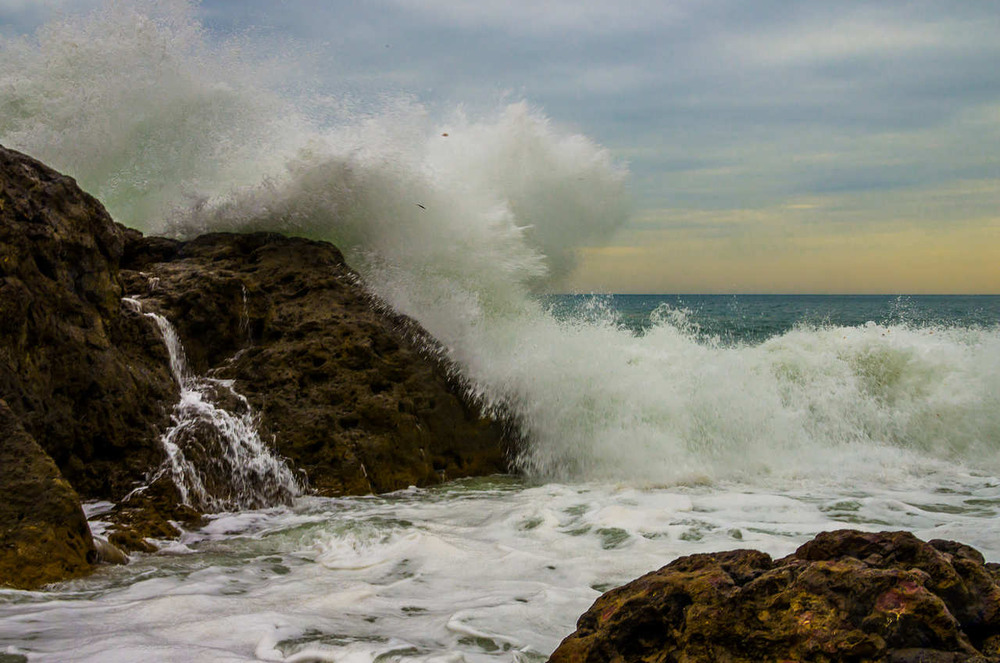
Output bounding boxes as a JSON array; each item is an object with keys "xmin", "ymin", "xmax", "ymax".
[{"xmin": 123, "ymin": 297, "xmax": 303, "ymax": 512}]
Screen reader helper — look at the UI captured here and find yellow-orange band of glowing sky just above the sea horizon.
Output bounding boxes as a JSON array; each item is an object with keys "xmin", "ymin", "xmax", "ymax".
[{"xmin": 559, "ymin": 203, "xmax": 1000, "ymax": 294}]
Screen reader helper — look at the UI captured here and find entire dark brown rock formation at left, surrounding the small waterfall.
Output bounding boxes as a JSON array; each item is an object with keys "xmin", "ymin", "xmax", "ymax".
[{"xmin": 0, "ymin": 146, "xmax": 506, "ymax": 586}]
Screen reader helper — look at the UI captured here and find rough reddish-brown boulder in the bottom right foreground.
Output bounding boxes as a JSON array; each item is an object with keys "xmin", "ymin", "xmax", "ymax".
[{"xmin": 549, "ymin": 530, "xmax": 1000, "ymax": 663}]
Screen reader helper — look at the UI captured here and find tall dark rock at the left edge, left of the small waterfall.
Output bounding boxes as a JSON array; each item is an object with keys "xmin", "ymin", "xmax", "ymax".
[{"xmin": 0, "ymin": 147, "xmax": 177, "ymax": 498}]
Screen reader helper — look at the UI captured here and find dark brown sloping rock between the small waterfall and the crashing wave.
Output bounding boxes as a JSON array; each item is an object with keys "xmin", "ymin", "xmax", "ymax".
[{"xmin": 123, "ymin": 233, "xmax": 506, "ymax": 495}]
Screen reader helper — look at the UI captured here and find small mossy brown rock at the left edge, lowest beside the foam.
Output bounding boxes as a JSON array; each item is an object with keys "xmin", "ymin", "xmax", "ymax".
[{"xmin": 0, "ymin": 400, "xmax": 95, "ymax": 589}]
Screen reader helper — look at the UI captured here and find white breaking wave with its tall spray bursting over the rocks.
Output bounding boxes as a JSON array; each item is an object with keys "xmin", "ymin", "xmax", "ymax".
[{"xmin": 0, "ymin": 2, "xmax": 1000, "ymax": 486}]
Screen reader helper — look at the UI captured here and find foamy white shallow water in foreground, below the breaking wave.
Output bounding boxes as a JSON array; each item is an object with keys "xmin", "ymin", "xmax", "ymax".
[{"xmin": 0, "ymin": 467, "xmax": 1000, "ymax": 663}]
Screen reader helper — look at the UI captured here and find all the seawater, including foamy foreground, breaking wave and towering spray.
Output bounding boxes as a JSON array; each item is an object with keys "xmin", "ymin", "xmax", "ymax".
[{"xmin": 0, "ymin": 1, "xmax": 1000, "ymax": 663}]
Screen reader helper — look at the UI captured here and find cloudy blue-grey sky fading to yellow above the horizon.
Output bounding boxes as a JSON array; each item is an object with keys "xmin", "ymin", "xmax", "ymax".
[{"xmin": 0, "ymin": 0, "xmax": 1000, "ymax": 294}]
